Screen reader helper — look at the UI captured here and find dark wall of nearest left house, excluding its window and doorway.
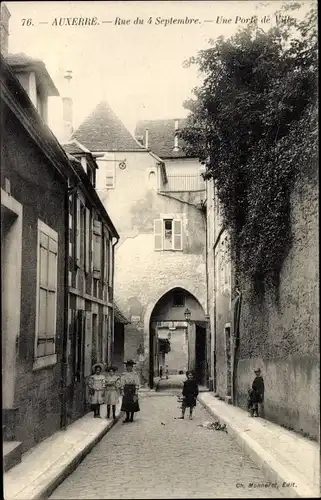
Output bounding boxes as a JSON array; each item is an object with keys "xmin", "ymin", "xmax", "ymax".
[{"xmin": 1, "ymin": 103, "xmax": 65, "ymax": 451}]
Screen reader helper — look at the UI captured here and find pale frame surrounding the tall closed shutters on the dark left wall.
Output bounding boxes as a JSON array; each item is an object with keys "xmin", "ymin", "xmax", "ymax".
[{"xmin": 33, "ymin": 219, "xmax": 59, "ymax": 370}]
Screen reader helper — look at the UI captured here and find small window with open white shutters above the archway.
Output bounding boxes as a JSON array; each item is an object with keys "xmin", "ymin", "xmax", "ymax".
[{"xmin": 154, "ymin": 219, "xmax": 183, "ymax": 250}]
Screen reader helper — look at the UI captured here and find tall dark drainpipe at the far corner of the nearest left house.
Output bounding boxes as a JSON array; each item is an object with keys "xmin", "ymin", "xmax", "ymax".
[{"xmin": 60, "ymin": 182, "xmax": 69, "ymax": 430}]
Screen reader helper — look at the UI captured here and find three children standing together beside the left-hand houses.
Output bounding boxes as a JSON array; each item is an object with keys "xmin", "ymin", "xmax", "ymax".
[{"xmin": 88, "ymin": 360, "xmax": 139, "ymax": 422}]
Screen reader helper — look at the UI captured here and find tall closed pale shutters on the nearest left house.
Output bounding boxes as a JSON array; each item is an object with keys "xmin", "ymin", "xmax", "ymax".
[{"xmin": 35, "ymin": 221, "xmax": 58, "ymax": 358}]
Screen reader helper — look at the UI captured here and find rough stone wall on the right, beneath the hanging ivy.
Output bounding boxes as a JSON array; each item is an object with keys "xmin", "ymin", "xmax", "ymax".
[{"xmin": 236, "ymin": 174, "xmax": 320, "ymax": 437}]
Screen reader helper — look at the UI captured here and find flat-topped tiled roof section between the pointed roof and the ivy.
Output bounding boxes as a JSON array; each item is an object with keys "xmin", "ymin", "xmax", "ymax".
[{"xmin": 135, "ymin": 119, "xmax": 194, "ymax": 159}]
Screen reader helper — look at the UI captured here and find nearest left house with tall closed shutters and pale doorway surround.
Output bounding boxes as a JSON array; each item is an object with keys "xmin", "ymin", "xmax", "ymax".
[{"xmin": 1, "ymin": 53, "xmax": 71, "ymax": 451}]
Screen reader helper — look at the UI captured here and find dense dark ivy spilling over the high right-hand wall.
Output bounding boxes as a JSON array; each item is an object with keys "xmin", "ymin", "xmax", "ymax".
[{"xmin": 180, "ymin": 5, "xmax": 317, "ymax": 293}]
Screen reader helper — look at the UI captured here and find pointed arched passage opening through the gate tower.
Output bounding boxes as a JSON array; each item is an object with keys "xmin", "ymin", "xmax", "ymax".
[{"xmin": 149, "ymin": 287, "xmax": 207, "ymax": 387}]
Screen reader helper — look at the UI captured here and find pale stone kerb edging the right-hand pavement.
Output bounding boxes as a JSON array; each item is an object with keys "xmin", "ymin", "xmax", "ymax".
[{"xmin": 198, "ymin": 395, "xmax": 319, "ymax": 498}]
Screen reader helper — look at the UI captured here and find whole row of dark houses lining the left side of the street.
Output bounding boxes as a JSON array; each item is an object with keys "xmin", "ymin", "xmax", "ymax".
[{"xmin": 0, "ymin": 15, "xmax": 121, "ymax": 460}]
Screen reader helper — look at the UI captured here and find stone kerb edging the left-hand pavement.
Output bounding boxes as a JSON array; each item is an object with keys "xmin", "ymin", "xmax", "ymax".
[{"xmin": 13, "ymin": 412, "xmax": 124, "ymax": 500}]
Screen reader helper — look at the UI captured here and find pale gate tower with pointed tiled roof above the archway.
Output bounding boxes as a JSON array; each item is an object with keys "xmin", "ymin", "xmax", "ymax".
[{"xmin": 74, "ymin": 111, "xmax": 206, "ymax": 383}]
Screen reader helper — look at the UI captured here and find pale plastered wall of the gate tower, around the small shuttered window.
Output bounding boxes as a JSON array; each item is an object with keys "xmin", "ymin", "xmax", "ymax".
[{"xmin": 97, "ymin": 152, "xmax": 206, "ymax": 382}]
